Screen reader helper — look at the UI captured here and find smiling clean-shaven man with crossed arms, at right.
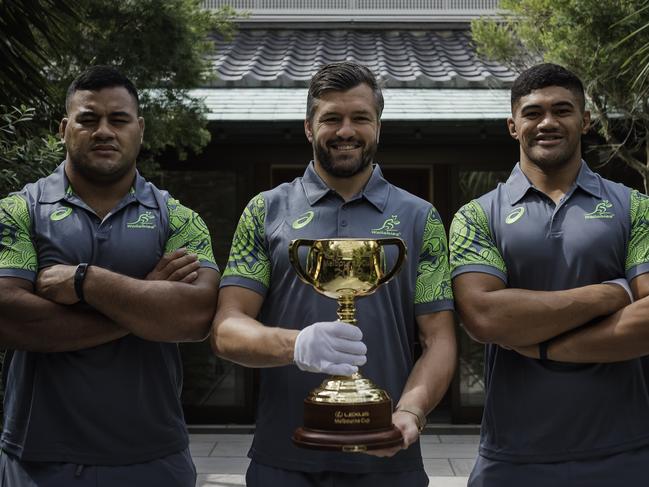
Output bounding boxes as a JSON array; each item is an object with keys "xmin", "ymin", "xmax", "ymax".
[{"xmin": 450, "ymin": 64, "xmax": 649, "ymax": 487}]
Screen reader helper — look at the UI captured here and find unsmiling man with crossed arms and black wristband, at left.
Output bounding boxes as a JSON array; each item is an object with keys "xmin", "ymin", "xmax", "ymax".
[{"xmin": 0, "ymin": 66, "xmax": 219, "ymax": 487}]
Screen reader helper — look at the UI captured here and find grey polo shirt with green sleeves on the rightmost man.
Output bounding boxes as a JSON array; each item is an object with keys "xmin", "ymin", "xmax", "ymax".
[{"xmin": 450, "ymin": 162, "xmax": 649, "ymax": 463}]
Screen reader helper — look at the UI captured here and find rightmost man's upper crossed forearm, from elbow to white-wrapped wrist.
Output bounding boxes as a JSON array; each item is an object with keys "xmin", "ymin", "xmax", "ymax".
[{"xmin": 458, "ymin": 284, "xmax": 628, "ymax": 347}]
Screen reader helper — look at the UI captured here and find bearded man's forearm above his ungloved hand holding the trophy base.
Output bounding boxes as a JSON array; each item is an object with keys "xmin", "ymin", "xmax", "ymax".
[{"xmin": 397, "ymin": 312, "xmax": 457, "ymax": 415}]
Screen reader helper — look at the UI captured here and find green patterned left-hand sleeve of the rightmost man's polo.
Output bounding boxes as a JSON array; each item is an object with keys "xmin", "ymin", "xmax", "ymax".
[{"xmin": 449, "ymin": 200, "xmax": 507, "ymax": 284}]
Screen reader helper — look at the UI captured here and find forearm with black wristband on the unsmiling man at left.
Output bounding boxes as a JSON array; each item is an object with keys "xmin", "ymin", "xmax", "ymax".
[{"xmin": 83, "ymin": 266, "xmax": 217, "ymax": 342}]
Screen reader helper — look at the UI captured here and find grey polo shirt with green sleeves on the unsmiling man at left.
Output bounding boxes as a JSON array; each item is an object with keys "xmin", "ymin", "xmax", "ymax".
[{"xmin": 0, "ymin": 164, "xmax": 217, "ymax": 465}]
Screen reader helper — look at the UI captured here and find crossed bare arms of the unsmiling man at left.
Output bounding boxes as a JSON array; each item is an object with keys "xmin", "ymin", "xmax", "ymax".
[{"xmin": 0, "ymin": 249, "xmax": 218, "ymax": 352}]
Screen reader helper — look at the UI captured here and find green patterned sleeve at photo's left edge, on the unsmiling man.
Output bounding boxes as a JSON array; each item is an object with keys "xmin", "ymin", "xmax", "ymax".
[{"xmin": 0, "ymin": 195, "xmax": 38, "ymax": 272}]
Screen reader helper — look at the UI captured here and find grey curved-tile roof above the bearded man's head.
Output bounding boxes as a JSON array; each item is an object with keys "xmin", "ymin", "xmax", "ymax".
[{"xmin": 213, "ymin": 29, "xmax": 516, "ymax": 88}]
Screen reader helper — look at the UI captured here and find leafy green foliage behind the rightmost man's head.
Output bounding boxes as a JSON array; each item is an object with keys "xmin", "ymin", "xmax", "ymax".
[{"xmin": 472, "ymin": 0, "xmax": 649, "ymax": 188}]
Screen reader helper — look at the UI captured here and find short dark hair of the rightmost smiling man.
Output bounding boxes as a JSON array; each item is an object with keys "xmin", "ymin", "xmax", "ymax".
[{"xmin": 512, "ymin": 63, "xmax": 586, "ymax": 113}]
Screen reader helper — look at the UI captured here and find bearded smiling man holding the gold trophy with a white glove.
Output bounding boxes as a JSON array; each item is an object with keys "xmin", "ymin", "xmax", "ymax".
[{"xmin": 212, "ymin": 62, "xmax": 456, "ymax": 487}]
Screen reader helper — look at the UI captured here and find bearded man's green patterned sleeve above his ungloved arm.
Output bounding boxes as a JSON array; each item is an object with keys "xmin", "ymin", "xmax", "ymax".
[{"xmin": 415, "ymin": 208, "xmax": 453, "ymax": 304}]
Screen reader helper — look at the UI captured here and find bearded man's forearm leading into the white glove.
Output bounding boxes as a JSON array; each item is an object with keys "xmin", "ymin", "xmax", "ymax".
[{"xmin": 210, "ymin": 308, "xmax": 298, "ymax": 367}]
